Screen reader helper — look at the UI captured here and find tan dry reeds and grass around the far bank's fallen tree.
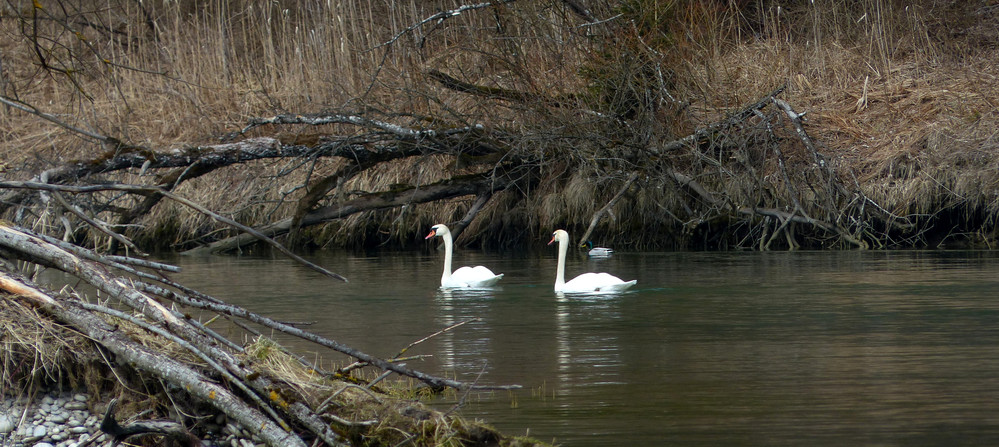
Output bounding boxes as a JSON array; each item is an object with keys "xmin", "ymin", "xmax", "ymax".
[{"xmin": 0, "ymin": 0, "xmax": 999, "ymax": 245}]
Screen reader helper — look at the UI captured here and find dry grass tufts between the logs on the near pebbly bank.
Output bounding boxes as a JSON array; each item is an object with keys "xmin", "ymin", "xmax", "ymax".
[{"xmin": 0, "ymin": 296, "xmax": 545, "ymax": 446}]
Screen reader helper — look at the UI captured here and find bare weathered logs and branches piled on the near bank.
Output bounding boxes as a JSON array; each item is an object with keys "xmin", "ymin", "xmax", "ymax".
[{"xmin": 0, "ymin": 224, "xmax": 518, "ymax": 446}]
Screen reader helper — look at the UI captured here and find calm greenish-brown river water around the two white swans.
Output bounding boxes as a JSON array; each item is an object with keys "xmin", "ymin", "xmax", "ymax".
[{"xmin": 170, "ymin": 248, "xmax": 999, "ymax": 446}]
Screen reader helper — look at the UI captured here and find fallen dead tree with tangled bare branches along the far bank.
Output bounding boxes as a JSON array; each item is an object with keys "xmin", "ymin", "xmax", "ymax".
[{"xmin": 0, "ymin": 72, "xmax": 900, "ymax": 258}]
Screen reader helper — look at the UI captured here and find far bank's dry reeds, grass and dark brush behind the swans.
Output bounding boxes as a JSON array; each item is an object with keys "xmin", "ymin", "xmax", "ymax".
[{"xmin": 0, "ymin": 0, "xmax": 999, "ymax": 249}]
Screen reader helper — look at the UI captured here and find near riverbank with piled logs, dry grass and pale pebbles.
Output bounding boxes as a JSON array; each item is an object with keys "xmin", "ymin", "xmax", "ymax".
[{"xmin": 0, "ymin": 256, "xmax": 546, "ymax": 447}]
